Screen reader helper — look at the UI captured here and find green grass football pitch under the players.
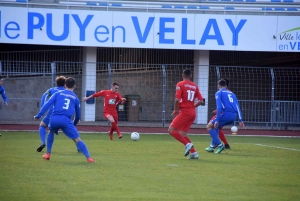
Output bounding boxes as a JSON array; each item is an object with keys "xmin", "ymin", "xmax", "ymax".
[{"xmin": 0, "ymin": 132, "xmax": 300, "ymax": 201}]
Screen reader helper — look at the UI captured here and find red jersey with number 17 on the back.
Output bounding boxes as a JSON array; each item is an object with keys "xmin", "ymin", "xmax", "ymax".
[{"xmin": 175, "ymin": 80, "xmax": 203, "ymax": 109}]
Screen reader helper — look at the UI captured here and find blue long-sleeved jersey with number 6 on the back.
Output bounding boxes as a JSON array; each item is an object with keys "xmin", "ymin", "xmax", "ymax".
[{"xmin": 215, "ymin": 88, "xmax": 242, "ymax": 122}]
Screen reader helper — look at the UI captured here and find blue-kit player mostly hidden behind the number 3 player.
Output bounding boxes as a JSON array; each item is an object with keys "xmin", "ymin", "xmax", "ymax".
[{"xmin": 36, "ymin": 76, "xmax": 66, "ymax": 152}]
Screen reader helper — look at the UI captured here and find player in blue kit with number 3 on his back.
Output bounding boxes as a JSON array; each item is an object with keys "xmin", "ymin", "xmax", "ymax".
[{"xmin": 34, "ymin": 77, "xmax": 95, "ymax": 163}]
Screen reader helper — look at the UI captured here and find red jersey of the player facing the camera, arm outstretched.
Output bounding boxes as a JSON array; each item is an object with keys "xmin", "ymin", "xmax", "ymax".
[{"xmin": 93, "ymin": 90, "xmax": 122, "ymax": 114}]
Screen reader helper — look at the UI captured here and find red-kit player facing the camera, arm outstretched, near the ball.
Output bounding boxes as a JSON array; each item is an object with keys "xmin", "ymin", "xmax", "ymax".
[{"xmin": 83, "ymin": 82, "xmax": 126, "ymax": 140}]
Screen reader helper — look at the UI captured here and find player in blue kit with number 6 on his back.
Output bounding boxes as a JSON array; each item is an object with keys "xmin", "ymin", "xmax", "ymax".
[{"xmin": 205, "ymin": 80, "xmax": 245, "ymax": 154}]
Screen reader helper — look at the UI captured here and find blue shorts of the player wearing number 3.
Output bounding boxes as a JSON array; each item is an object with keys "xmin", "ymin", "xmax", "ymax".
[{"xmin": 49, "ymin": 115, "xmax": 80, "ymax": 139}]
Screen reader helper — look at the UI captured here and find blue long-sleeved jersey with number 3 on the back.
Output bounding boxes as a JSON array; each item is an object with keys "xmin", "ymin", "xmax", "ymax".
[{"xmin": 36, "ymin": 90, "xmax": 80, "ymax": 125}]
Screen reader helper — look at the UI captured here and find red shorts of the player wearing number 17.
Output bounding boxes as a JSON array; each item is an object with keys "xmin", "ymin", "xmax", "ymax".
[{"xmin": 171, "ymin": 109, "xmax": 196, "ymax": 132}]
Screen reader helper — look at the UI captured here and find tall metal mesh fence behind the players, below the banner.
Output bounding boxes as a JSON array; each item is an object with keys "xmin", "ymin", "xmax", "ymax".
[{"xmin": 0, "ymin": 61, "xmax": 300, "ymax": 129}]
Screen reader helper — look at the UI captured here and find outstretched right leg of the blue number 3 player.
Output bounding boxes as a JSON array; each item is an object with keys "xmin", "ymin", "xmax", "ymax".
[{"xmin": 62, "ymin": 121, "xmax": 95, "ymax": 163}]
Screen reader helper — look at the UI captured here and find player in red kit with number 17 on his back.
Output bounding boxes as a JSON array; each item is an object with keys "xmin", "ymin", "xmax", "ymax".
[{"xmin": 168, "ymin": 69, "xmax": 203, "ymax": 159}]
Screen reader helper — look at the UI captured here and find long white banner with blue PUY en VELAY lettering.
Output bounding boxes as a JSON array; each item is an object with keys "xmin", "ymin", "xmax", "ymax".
[{"xmin": 0, "ymin": 7, "xmax": 300, "ymax": 52}]
